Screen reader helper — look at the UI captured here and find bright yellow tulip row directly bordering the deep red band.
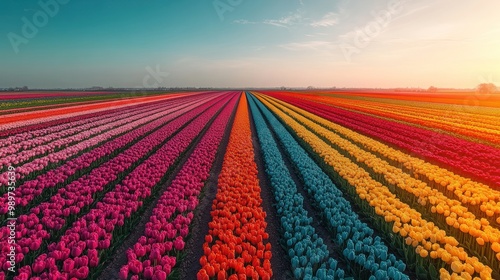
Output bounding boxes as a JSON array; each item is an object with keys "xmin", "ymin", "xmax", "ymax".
[{"xmin": 266, "ymin": 95, "xmax": 500, "ymax": 222}]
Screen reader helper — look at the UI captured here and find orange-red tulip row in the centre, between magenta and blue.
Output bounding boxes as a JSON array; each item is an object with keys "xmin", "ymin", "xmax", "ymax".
[{"xmin": 197, "ymin": 94, "xmax": 273, "ymax": 279}]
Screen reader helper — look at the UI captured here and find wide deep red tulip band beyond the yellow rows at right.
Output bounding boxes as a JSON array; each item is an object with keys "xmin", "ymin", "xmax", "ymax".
[{"xmin": 269, "ymin": 93, "xmax": 500, "ymax": 188}]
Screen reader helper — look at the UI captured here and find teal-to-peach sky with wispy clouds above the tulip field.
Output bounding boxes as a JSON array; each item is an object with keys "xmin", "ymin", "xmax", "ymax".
[{"xmin": 0, "ymin": 0, "xmax": 500, "ymax": 88}]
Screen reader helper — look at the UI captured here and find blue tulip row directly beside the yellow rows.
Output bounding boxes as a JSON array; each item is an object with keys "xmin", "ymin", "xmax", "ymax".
[{"xmin": 250, "ymin": 93, "xmax": 409, "ymax": 279}]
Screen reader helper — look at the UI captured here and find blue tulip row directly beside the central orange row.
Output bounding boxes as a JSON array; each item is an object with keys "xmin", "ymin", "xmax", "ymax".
[{"xmin": 248, "ymin": 95, "xmax": 344, "ymax": 279}]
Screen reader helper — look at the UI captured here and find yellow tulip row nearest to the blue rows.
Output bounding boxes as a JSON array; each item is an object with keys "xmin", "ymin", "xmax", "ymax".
[{"xmin": 257, "ymin": 95, "xmax": 493, "ymax": 279}]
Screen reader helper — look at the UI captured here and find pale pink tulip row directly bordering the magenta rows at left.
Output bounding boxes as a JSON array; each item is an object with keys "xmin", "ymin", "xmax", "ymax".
[{"xmin": 0, "ymin": 95, "xmax": 219, "ymax": 187}]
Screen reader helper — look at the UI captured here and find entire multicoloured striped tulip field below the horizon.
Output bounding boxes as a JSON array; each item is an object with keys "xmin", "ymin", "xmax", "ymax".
[{"xmin": 0, "ymin": 91, "xmax": 500, "ymax": 280}]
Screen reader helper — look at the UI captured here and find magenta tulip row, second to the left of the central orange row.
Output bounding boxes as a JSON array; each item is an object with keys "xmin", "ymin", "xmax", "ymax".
[{"xmin": 14, "ymin": 93, "xmax": 236, "ymax": 279}]
